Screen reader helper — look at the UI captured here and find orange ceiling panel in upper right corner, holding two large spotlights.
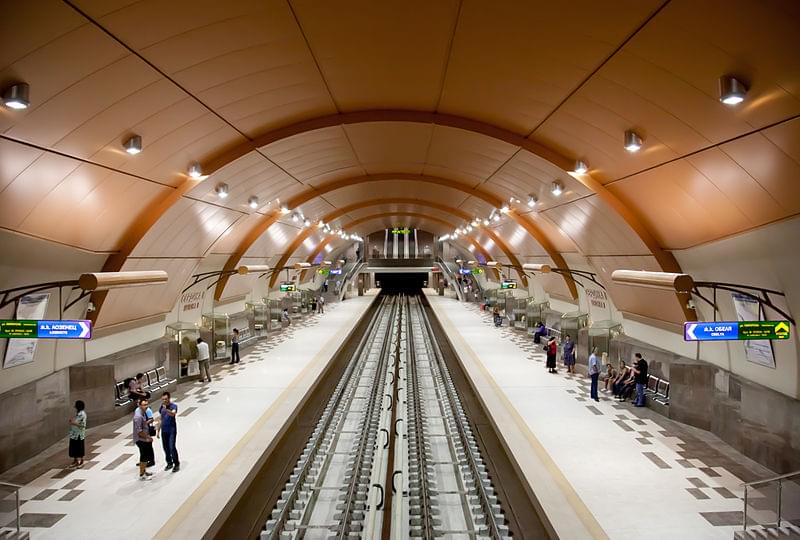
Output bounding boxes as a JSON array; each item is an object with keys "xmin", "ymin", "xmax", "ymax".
[{"xmin": 533, "ymin": 0, "xmax": 800, "ymax": 181}]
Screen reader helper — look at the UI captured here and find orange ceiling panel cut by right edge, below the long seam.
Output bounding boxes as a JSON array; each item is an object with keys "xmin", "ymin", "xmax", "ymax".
[{"xmin": 720, "ymin": 129, "xmax": 800, "ymax": 215}]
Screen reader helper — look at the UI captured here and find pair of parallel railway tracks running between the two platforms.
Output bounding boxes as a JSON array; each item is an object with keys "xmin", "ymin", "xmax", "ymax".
[{"xmin": 261, "ymin": 295, "xmax": 510, "ymax": 540}]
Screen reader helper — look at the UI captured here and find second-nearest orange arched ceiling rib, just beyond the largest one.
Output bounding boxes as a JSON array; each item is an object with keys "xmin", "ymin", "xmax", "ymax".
[{"xmin": 214, "ymin": 179, "xmax": 556, "ymax": 299}]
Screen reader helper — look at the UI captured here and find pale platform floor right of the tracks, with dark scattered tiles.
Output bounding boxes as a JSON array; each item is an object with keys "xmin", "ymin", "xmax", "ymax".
[{"xmin": 425, "ymin": 289, "xmax": 774, "ymax": 540}]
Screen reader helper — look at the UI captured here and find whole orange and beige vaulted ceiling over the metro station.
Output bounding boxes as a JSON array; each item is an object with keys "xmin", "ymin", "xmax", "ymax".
[{"xmin": 0, "ymin": 0, "xmax": 800, "ymax": 325}]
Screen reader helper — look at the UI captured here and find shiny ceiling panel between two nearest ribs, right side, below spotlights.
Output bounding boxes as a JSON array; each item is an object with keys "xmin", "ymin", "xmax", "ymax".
[{"xmin": 542, "ymin": 196, "xmax": 648, "ymax": 255}]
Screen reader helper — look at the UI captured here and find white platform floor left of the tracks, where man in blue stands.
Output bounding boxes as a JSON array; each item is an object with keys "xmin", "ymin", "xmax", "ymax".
[{"xmin": 0, "ymin": 296, "xmax": 378, "ymax": 540}]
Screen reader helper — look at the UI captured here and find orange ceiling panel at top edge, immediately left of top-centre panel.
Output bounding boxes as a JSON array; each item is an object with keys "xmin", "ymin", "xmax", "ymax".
[{"xmin": 78, "ymin": 0, "xmax": 335, "ymax": 136}]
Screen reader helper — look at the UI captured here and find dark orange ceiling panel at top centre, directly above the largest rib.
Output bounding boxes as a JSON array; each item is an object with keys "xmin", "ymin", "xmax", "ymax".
[{"xmin": 291, "ymin": 0, "xmax": 458, "ymax": 111}]
